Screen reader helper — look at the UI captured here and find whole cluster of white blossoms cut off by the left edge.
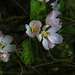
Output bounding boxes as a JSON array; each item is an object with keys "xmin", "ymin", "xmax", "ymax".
[{"xmin": 0, "ymin": 31, "xmax": 16, "ymax": 62}]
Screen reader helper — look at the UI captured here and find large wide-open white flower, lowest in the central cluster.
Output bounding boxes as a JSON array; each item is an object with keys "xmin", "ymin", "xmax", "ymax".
[{"xmin": 37, "ymin": 28, "xmax": 63, "ymax": 50}]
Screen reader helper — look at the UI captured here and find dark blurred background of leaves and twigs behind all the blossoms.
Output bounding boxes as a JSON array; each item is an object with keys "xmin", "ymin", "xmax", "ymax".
[{"xmin": 0, "ymin": 0, "xmax": 75, "ymax": 75}]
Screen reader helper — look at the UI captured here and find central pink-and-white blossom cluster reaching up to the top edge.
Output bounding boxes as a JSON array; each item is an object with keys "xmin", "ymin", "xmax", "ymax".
[{"xmin": 25, "ymin": 0, "xmax": 63, "ymax": 50}]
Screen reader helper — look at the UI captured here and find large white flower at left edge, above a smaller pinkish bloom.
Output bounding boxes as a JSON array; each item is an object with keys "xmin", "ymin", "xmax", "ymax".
[{"xmin": 0, "ymin": 31, "xmax": 16, "ymax": 53}]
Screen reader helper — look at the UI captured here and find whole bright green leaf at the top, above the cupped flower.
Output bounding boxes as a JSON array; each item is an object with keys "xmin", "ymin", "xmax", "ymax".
[{"xmin": 30, "ymin": 0, "xmax": 46, "ymax": 20}]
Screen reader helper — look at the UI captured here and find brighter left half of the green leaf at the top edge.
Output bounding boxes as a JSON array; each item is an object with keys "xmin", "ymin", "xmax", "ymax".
[{"xmin": 30, "ymin": 0, "xmax": 40, "ymax": 20}]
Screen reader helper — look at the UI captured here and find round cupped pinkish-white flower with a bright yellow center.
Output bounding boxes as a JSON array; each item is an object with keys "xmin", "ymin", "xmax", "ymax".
[{"xmin": 25, "ymin": 20, "xmax": 42, "ymax": 38}]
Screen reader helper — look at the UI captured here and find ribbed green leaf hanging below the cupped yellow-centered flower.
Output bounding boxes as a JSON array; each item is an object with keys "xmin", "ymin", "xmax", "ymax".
[{"xmin": 21, "ymin": 38, "xmax": 38, "ymax": 65}]
